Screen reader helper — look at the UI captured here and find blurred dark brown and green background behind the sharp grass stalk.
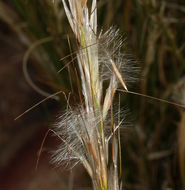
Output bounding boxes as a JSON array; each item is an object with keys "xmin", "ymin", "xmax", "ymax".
[{"xmin": 0, "ymin": 0, "xmax": 185, "ymax": 190}]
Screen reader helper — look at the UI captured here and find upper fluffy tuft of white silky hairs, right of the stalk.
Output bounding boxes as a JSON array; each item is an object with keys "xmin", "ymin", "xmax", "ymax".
[{"xmin": 98, "ymin": 27, "xmax": 139, "ymax": 88}]
